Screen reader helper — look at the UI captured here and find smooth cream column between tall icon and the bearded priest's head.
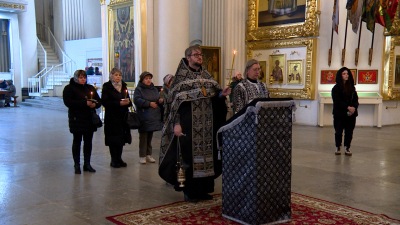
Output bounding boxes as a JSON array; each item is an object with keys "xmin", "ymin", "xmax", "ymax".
[{"xmin": 152, "ymin": 0, "xmax": 189, "ymax": 85}]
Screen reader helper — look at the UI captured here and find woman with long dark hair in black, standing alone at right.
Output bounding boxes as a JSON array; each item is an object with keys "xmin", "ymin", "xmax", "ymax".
[{"xmin": 332, "ymin": 67, "xmax": 358, "ymax": 156}]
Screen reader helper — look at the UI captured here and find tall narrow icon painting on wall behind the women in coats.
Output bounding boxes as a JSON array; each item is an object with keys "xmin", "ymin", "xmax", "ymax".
[{"xmin": 108, "ymin": 1, "xmax": 135, "ymax": 84}]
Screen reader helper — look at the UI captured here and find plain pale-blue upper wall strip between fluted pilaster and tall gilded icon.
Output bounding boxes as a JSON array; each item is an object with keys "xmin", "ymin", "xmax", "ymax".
[{"xmin": 83, "ymin": 0, "xmax": 101, "ymax": 38}]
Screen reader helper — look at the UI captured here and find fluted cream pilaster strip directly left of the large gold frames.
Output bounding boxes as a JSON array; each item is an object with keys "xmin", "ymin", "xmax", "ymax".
[{"xmin": 222, "ymin": 0, "xmax": 247, "ymax": 84}]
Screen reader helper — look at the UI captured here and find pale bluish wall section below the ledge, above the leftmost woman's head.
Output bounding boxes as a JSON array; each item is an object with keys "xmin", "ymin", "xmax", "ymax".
[{"xmin": 64, "ymin": 37, "xmax": 105, "ymax": 70}]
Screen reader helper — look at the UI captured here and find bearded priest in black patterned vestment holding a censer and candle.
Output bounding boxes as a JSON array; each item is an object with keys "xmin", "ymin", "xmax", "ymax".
[{"xmin": 159, "ymin": 46, "xmax": 230, "ymax": 202}]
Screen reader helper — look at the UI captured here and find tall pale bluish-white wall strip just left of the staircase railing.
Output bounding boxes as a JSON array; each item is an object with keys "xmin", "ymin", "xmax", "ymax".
[{"xmin": 18, "ymin": 0, "xmax": 38, "ymax": 87}]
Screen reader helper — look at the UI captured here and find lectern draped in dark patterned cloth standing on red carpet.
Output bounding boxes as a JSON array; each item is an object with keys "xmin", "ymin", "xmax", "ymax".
[{"xmin": 218, "ymin": 99, "xmax": 296, "ymax": 224}]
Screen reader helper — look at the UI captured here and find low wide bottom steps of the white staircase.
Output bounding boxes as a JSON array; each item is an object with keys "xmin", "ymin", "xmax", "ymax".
[{"xmin": 18, "ymin": 97, "xmax": 68, "ymax": 112}]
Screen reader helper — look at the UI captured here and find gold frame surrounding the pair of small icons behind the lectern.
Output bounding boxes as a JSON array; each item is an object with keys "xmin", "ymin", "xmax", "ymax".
[{"xmin": 246, "ymin": 38, "xmax": 317, "ymax": 100}]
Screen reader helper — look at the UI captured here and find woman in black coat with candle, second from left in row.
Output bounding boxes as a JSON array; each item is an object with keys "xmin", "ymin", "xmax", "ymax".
[{"xmin": 101, "ymin": 68, "xmax": 132, "ymax": 168}]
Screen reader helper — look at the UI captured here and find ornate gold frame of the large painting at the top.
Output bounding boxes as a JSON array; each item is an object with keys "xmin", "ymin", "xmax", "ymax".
[{"xmin": 246, "ymin": 0, "xmax": 321, "ymax": 41}]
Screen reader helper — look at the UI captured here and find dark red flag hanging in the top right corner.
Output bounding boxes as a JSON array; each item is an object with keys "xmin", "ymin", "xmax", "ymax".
[{"xmin": 375, "ymin": 0, "xmax": 399, "ymax": 31}]
